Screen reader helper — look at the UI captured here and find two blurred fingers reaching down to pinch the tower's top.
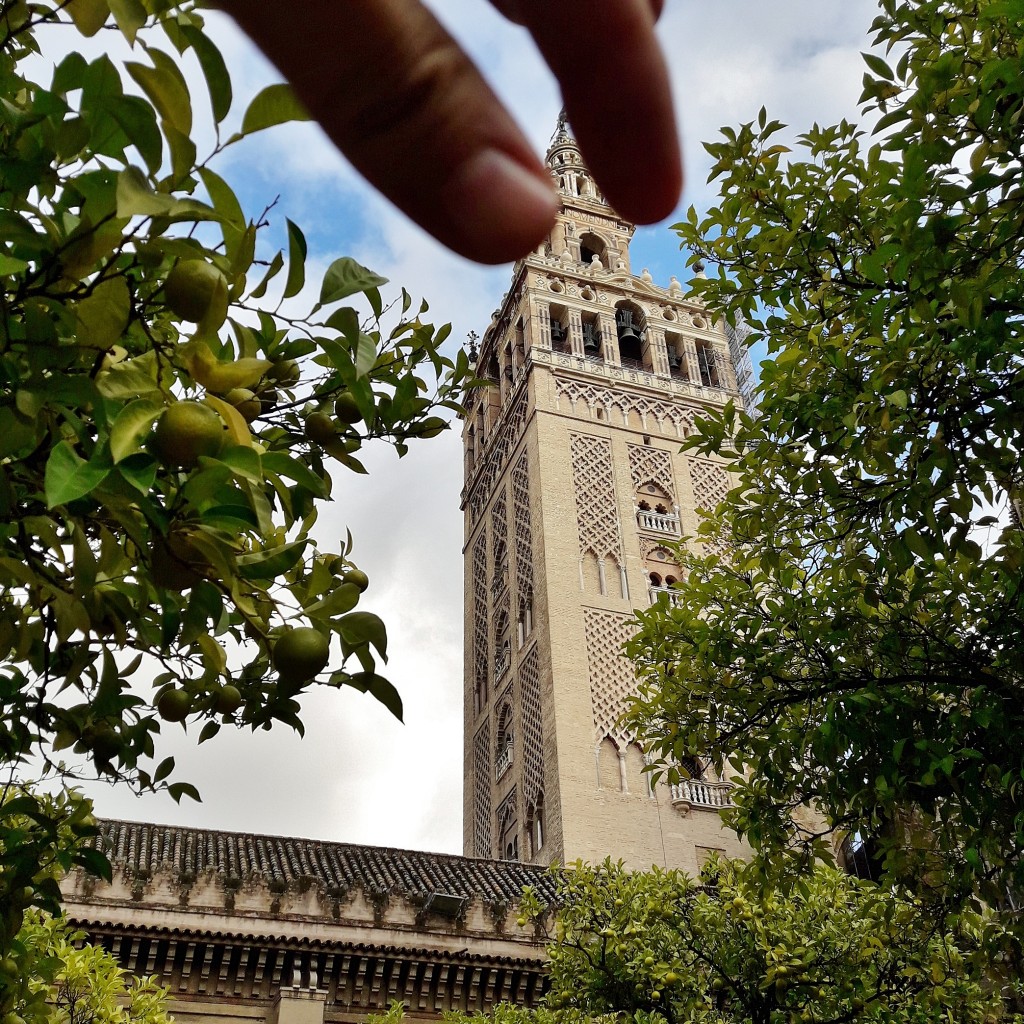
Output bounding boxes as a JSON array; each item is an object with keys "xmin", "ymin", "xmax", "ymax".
[{"xmin": 220, "ymin": 0, "xmax": 682, "ymax": 263}]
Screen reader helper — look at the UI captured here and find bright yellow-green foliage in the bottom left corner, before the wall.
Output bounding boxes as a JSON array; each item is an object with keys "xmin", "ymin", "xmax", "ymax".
[{"xmin": 0, "ymin": 910, "xmax": 171, "ymax": 1024}]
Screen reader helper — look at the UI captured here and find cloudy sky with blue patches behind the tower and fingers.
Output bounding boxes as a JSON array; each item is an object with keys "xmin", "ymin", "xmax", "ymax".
[{"xmin": 79, "ymin": 0, "xmax": 876, "ymax": 853}]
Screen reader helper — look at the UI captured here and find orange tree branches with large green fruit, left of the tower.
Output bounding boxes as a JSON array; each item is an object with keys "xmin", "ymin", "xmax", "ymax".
[{"xmin": 0, "ymin": 0, "xmax": 472, "ymax": 952}]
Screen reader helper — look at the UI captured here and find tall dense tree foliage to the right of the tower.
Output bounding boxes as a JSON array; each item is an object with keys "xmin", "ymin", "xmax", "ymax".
[{"xmin": 630, "ymin": 0, "xmax": 1024, "ymax": 917}]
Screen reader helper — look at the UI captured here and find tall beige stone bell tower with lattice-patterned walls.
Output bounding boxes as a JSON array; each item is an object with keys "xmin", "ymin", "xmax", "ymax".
[{"xmin": 462, "ymin": 119, "xmax": 742, "ymax": 872}]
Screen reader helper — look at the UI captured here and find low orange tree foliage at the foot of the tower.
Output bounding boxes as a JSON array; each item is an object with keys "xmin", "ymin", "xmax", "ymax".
[{"xmin": 446, "ymin": 860, "xmax": 1001, "ymax": 1024}]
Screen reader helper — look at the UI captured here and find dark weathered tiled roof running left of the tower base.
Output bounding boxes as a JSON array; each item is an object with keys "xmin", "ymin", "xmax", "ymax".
[{"xmin": 94, "ymin": 819, "xmax": 555, "ymax": 903}]
